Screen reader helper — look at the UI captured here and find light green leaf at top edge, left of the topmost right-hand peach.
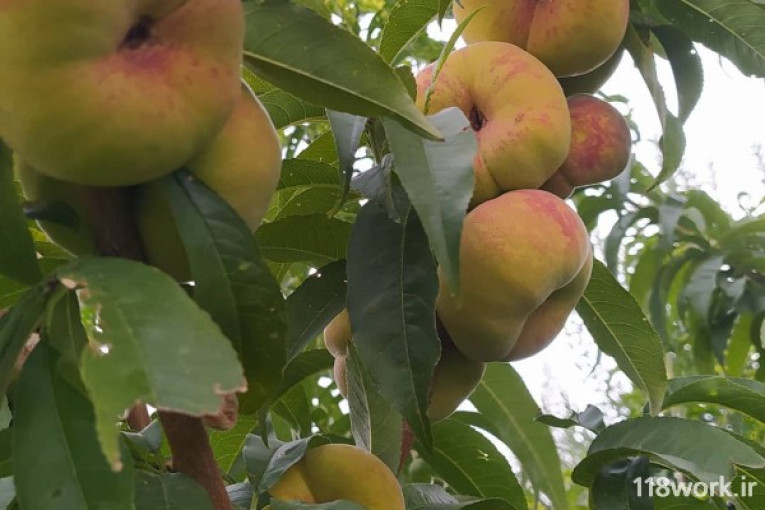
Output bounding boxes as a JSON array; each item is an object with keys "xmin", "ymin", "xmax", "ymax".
[{"xmin": 380, "ymin": 0, "xmax": 440, "ymax": 63}]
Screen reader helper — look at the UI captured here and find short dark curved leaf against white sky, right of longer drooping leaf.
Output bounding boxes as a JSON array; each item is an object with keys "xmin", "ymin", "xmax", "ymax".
[{"xmin": 651, "ymin": 25, "xmax": 704, "ymax": 123}]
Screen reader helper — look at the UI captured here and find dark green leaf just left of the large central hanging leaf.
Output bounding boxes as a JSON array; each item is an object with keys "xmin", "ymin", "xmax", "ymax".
[{"xmin": 287, "ymin": 260, "xmax": 348, "ymax": 358}]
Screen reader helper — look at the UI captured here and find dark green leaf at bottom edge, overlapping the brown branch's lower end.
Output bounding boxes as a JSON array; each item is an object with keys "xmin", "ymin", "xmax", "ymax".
[{"xmin": 135, "ymin": 471, "xmax": 213, "ymax": 510}]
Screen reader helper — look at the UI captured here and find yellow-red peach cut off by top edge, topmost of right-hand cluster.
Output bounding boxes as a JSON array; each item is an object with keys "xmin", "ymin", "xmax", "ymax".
[{"xmin": 454, "ymin": 0, "xmax": 630, "ymax": 76}]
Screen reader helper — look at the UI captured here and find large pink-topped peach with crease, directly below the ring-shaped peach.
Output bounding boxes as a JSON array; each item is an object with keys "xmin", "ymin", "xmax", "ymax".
[{"xmin": 436, "ymin": 190, "xmax": 592, "ymax": 361}]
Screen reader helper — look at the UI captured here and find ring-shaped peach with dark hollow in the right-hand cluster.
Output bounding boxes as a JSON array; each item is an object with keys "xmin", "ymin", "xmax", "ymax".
[{"xmin": 417, "ymin": 42, "xmax": 571, "ymax": 207}]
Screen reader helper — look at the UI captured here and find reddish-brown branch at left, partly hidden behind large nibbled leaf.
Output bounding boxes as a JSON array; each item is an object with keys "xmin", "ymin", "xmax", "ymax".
[{"xmin": 83, "ymin": 187, "xmax": 232, "ymax": 510}]
